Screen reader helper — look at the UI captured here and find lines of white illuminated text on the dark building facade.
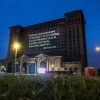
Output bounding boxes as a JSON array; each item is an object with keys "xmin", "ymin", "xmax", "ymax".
[{"xmin": 28, "ymin": 30, "xmax": 60, "ymax": 49}]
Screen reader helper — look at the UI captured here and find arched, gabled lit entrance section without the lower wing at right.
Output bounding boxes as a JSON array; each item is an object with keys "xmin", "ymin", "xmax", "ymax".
[{"xmin": 16, "ymin": 53, "xmax": 63, "ymax": 74}]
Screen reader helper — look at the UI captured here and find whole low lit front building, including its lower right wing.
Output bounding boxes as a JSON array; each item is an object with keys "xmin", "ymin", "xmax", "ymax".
[{"xmin": 10, "ymin": 53, "xmax": 82, "ymax": 74}]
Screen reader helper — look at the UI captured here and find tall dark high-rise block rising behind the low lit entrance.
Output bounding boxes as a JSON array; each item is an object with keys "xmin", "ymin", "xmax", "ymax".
[{"xmin": 8, "ymin": 10, "xmax": 87, "ymax": 73}]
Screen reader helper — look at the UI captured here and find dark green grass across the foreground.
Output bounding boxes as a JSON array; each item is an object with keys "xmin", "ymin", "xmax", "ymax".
[{"xmin": 0, "ymin": 75, "xmax": 100, "ymax": 100}]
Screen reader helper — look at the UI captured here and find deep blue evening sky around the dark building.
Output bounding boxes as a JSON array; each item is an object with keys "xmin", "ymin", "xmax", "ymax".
[{"xmin": 0, "ymin": 0, "xmax": 100, "ymax": 67}]
